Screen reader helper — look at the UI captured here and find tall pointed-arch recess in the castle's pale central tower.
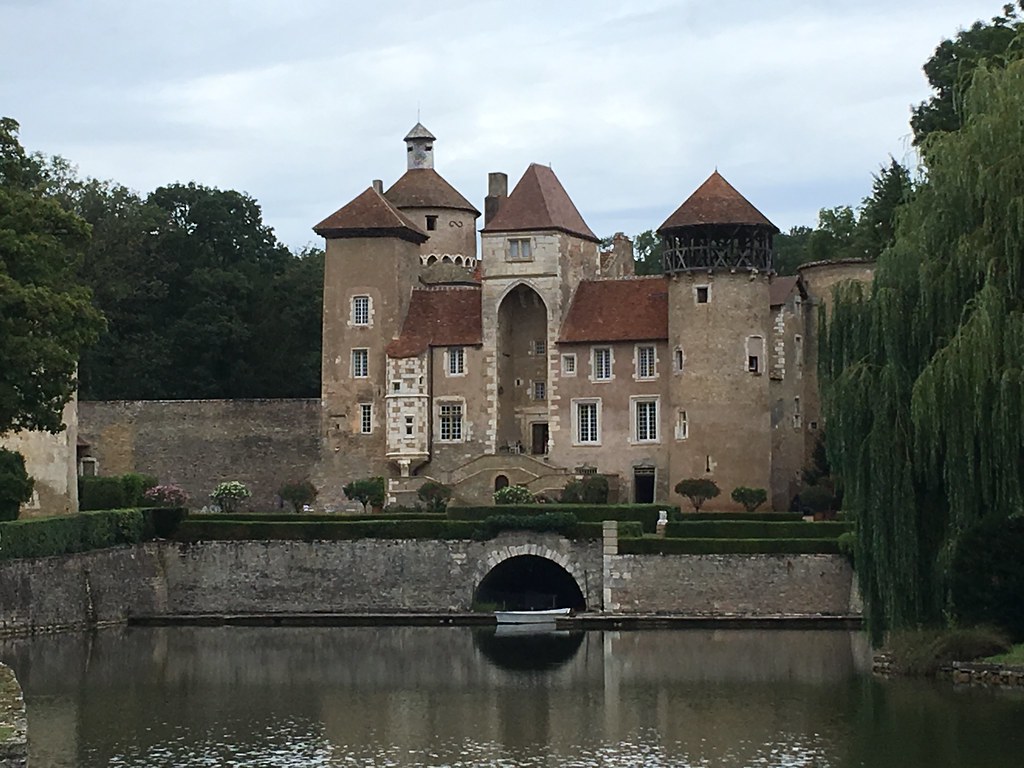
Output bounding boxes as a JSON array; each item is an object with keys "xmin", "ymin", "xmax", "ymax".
[{"xmin": 497, "ymin": 284, "xmax": 548, "ymax": 453}]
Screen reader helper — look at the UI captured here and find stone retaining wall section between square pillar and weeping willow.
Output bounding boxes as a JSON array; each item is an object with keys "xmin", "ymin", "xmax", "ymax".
[{"xmin": 604, "ymin": 555, "xmax": 859, "ymax": 616}]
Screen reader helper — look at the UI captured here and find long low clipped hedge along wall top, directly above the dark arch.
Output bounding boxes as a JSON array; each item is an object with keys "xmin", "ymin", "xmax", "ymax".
[{"xmin": 174, "ymin": 513, "xmax": 643, "ymax": 542}]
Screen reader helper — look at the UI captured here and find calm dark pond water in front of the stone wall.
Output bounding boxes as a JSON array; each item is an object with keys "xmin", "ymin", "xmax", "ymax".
[{"xmin": 0, "ymin": 627, "xmax": 1024, "ymax": 768}]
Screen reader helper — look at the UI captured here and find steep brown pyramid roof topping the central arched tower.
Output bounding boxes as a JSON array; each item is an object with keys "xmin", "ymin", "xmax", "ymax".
[{"xmin": 483, "ymin": 163, "xmax": 600, "ymax": 243}]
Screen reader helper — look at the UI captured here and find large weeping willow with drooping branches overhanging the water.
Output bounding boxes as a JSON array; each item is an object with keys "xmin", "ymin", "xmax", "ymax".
[{"xmin": 820, "ymin": 45, "xmax": 1024, "ymax": 639}]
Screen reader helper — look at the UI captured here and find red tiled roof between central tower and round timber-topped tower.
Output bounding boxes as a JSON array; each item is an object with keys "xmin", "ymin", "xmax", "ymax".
[{"xmin": 559, "ymin": 275, "xmax": 669, "ymax": 342}]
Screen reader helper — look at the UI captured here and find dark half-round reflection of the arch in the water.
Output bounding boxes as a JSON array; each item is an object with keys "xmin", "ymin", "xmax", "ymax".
[{"xmin": 473, "ymin": 623, "xmax": 586, "ymax": 672}]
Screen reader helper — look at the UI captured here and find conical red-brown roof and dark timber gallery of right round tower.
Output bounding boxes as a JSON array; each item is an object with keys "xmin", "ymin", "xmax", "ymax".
[{"xmin": 657, "ymin": 171, "xmax": 778, "ymax": 273}]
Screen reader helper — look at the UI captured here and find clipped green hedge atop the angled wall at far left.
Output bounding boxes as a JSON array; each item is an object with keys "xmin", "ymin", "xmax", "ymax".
[{"xmin": 0, "ymin": 507, "xmax": 185, "ymax": 560}]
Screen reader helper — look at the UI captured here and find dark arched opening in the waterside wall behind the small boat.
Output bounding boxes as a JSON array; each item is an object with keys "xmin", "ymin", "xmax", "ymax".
[{"xmin": 473, "ymin": 555, "xmax": 587, "ymax": 610}]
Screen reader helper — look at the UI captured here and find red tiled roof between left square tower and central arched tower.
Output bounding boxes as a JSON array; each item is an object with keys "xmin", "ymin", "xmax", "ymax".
[{"xmin": 387, "ymin": 286, "xmax": 483, "ymax": 357}]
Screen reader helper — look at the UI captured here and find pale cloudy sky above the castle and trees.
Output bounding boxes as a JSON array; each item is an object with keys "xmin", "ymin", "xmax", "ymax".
[{"xmin": 0, "ymin": 0, "xmax": 1002, "ymax": 249}]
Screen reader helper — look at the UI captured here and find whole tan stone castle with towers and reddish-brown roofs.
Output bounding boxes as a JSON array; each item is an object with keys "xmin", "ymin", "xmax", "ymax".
[{"xmin": 314, "ymin": 124, "xmax": 870, "ymax": 509}]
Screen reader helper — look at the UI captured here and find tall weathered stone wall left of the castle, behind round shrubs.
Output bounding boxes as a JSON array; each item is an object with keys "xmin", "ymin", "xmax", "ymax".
[{"xmin": 79, "ymin": 399, "xmax": 319, "ymax": 510}]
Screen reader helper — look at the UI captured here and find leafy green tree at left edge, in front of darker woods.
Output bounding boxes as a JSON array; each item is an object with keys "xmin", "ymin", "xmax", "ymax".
[{"xmin": 0, "ymin": 118, "xmax": 103, "ymax": 434}]
